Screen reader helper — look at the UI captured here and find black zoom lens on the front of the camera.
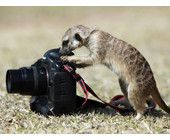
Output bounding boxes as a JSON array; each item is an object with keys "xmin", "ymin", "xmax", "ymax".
[{"xmin": 6, "ymin": 67, "xmax": 47, "ymax": 95}]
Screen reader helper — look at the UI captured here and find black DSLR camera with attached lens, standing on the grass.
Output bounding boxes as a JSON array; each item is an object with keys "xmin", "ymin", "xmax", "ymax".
[{"xmin": 6, "ymin": 48, "xmax": 76, "ymax": 116}]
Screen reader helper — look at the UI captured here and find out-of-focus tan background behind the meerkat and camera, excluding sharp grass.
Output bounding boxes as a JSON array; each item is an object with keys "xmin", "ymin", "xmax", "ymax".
[{"xmin": 0, "ymin": 7, "xmax": 170, "ymax": 100}]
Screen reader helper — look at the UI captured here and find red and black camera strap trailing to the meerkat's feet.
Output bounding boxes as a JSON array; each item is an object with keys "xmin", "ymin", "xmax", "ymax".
[{"xmin": 63, "ymin": 64, "xmax": 156, "ymax": 112}]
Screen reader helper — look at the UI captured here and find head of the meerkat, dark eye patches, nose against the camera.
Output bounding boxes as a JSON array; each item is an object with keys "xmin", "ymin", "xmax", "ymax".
[{"xmin": 60, "ymin": 25, "xmax": 95, "ymax": 55}]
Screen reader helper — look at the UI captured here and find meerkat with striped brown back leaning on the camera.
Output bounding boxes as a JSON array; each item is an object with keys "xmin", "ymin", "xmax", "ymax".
[{"xmin": 60, "ymin": 25, "xmax": 170, "ymax": 119}]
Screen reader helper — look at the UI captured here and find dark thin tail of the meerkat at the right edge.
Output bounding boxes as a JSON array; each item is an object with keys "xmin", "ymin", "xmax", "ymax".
[{"xmin": 151, "ymin": 88, "xmax": 170, "ymax": 113}]
